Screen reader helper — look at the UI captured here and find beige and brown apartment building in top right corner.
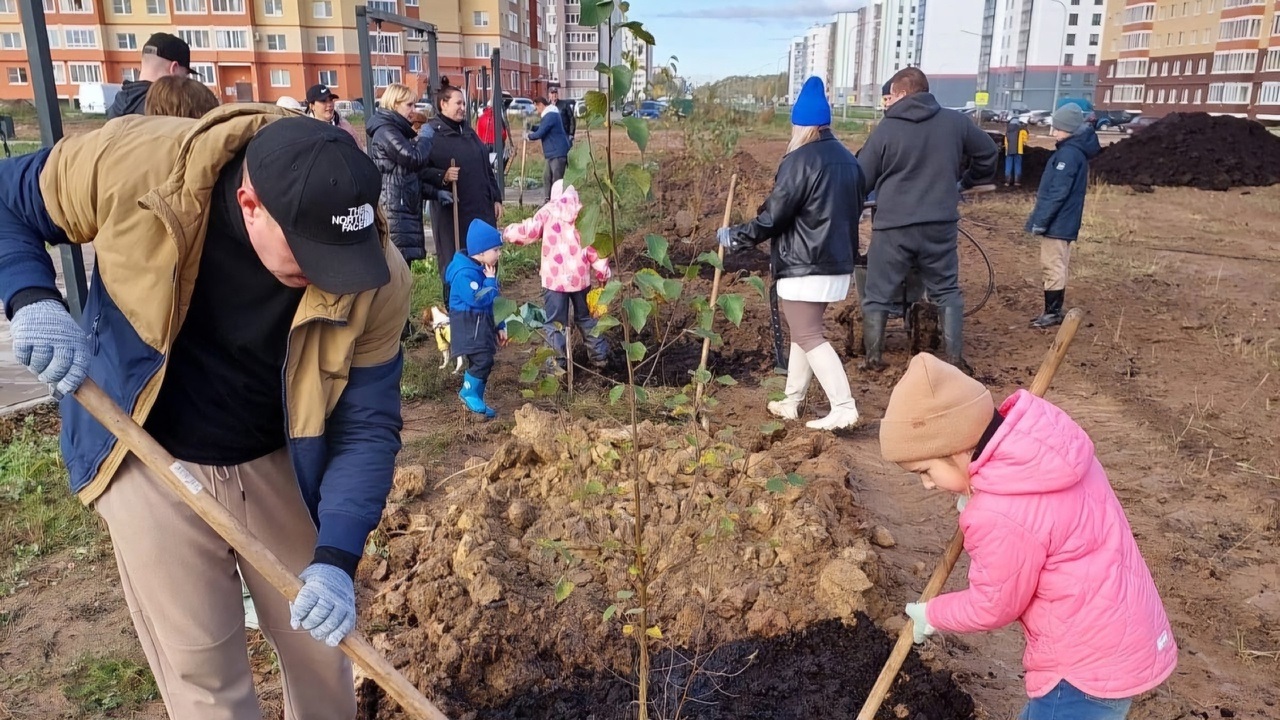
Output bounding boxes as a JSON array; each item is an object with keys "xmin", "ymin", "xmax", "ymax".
[{"xmin": 1100, "ymin": 0, "xmax": 1280, "ymax": 120}]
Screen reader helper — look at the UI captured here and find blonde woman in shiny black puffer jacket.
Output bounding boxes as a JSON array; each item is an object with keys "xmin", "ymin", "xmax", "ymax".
[{"xmin": 365, "ymin": 83, "xmax": 452, "ymax": 263}]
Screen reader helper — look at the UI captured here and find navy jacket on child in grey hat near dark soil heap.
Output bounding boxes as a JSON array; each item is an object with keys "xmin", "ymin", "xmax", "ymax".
[{"xmin": 1027, "ymin": 126, "xmax": 1102, "ymax": 242}]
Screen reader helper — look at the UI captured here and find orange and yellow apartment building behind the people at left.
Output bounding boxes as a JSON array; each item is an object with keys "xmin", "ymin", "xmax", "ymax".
[{"xmin": 0, "ymin": 0, "xmax": 544, "ymax": 102}]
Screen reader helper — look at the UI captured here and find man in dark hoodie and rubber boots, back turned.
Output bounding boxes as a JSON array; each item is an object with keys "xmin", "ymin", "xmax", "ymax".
[{"xmin": 858, "ymin": 68, "xmax": 1000, "ymax": 370}]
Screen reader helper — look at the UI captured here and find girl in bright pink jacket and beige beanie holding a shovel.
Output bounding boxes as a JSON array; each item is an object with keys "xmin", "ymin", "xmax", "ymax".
[{"xmin": 881, "ymin": 354, "xmax": 1178, "ymax": 720}]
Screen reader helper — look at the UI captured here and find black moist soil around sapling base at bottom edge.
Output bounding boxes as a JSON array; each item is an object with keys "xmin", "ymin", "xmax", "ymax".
[{"xmin": 477, "ymin": 612, "xmax": 973, "ymax": 720}]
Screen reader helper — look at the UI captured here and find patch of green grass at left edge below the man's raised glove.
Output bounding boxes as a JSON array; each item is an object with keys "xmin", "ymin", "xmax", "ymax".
[{"xmin": 0, "ymin": 418, "xmax": 104, "ymax": 594}]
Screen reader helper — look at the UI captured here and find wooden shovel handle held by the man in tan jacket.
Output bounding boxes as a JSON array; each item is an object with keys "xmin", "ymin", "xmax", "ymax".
[{"xmin": 74, "ymin": 379, "xmax": 448, "ymax": 720}]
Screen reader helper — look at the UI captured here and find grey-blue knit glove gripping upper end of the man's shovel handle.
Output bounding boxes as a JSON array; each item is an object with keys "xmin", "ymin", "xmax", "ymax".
[{"xmin": 12, "ymin": 300, "xmax": 90, "ymax": 398}]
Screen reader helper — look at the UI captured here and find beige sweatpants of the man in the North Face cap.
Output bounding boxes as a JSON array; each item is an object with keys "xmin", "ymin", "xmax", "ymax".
[{"xmin": 95, "ymin": 450, "xmax": 356, "ymax": 720}]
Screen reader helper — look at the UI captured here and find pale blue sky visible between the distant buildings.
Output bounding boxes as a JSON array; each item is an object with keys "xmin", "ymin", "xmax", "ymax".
[{"xmin": 631, "ymin": 0, "xmax": 867, "ymax": 82}]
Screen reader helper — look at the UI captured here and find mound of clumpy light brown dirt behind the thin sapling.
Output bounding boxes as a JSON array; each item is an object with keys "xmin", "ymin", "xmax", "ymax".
[{"xmin": 362, "ymin": 406, "xmax": 947, "ymax": 716}]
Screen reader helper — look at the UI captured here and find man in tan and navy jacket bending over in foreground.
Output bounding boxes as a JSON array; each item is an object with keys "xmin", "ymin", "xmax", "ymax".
[{"xmin": 0, "ymin": 105, "xmax": 411, "ymax": 720}]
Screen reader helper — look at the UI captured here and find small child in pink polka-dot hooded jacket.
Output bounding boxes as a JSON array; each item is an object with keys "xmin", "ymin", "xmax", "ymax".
[{"xmin": 502, "ymin": 181, "xmax": 613, "ymax": 368}]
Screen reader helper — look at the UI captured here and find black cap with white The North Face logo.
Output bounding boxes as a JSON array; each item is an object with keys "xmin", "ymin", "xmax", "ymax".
[{"xmin": 244, "ymin": 117, "xmax": 390, "ymax": 295}]
